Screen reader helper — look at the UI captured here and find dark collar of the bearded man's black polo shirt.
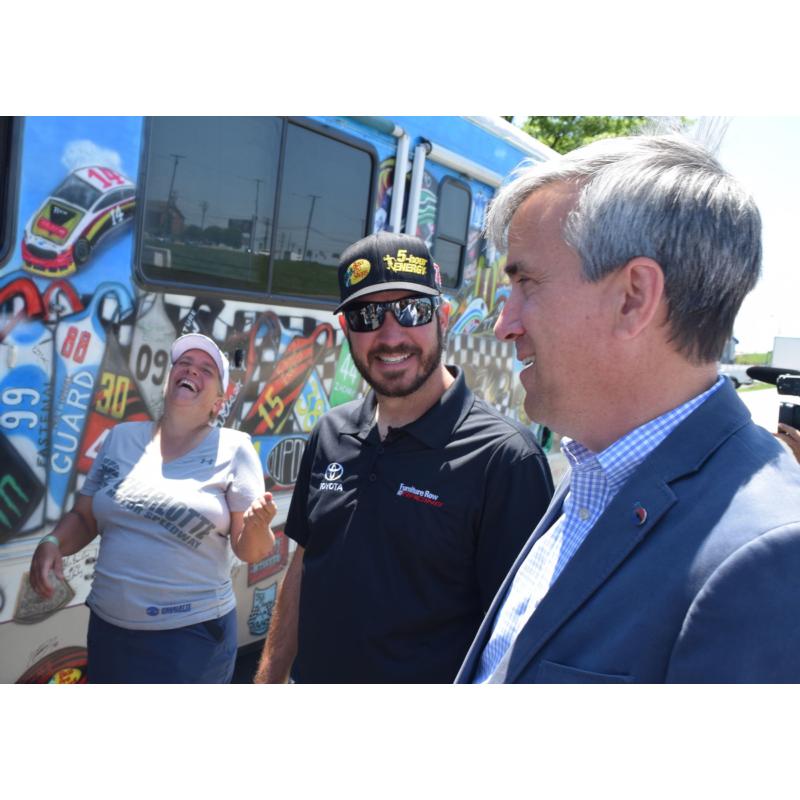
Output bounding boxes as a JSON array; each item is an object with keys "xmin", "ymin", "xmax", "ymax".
[{"xmin": 341, "ymin": 364, "xmax": 475, "ymax": 448}]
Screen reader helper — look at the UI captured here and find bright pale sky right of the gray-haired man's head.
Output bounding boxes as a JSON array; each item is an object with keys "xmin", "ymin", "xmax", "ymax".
[{"xmin": 717, "ymin": 117, "xmax": 800, "ymax": 352}]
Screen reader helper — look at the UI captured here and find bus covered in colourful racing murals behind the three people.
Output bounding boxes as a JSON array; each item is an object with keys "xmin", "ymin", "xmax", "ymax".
[{"xmin": 0, "ymin": 117, "xmax": 555, "ymax": 683}]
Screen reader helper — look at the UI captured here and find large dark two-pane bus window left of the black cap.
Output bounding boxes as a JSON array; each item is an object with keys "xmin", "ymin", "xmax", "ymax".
[{"xmin": 139, "ymin": 117, "xmax": 374, "ymax": 301}]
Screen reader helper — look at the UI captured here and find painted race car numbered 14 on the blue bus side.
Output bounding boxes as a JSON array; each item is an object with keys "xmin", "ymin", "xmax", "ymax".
[{"xmin": 22, "ymin": 166, "xmax": 136, "ymax": 278}]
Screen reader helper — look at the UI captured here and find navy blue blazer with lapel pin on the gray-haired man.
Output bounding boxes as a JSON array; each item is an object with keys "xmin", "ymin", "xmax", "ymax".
[{"xmin": 456, "ymin": 382, "xmax": 800, "ymax": 683}]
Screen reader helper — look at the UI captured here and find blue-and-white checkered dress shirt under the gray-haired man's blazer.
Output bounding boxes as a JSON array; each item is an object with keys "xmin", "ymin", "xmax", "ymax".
[{"xmin": 474, "ymin": 378, "xmax": 725, "ymax": 683}]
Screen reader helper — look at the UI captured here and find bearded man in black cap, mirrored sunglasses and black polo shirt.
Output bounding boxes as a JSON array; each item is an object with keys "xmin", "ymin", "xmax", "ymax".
[{"xmin": 256, "ymin": 232, "xmax": 552, "ymax": 683}]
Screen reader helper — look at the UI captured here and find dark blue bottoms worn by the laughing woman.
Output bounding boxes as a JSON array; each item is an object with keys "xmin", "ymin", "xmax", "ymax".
[{"xmin": 87, "ymin": 609, "xmax": 236, "ymax": 683}]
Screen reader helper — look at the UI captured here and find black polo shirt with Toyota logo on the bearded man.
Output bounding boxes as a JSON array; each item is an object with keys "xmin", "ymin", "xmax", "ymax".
[{"xmin": 286, "ymin": 367, "xmax": 553, "ymax": 683}]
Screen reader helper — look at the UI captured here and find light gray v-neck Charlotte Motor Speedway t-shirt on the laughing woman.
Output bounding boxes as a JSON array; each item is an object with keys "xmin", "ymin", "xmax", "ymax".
[{"xmin": 81, "ymin": 422, "xmax": 264, "ymax": 630}]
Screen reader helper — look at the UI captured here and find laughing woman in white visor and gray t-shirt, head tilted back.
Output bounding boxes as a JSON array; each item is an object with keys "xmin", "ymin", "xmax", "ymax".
[{"xmin": 30, "ymin": 333, "xmax": 277, "ymax": 683}]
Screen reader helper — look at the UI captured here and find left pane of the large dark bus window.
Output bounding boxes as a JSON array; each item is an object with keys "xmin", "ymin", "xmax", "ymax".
[{"xmin": 140, "ymin": 117, "xmax": 283, "ymax": 292}]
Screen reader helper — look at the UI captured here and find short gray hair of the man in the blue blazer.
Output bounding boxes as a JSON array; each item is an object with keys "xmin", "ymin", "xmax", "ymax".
[{"xmin": 486, "ymin": 135, "xmax": 761, "ymax": 363}]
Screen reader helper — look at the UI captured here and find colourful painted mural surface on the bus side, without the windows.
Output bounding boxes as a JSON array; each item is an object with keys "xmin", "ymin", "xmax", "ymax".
[{"xmin": 0, "ymin": 118, "xmax": 536, "ymax": 682}]
